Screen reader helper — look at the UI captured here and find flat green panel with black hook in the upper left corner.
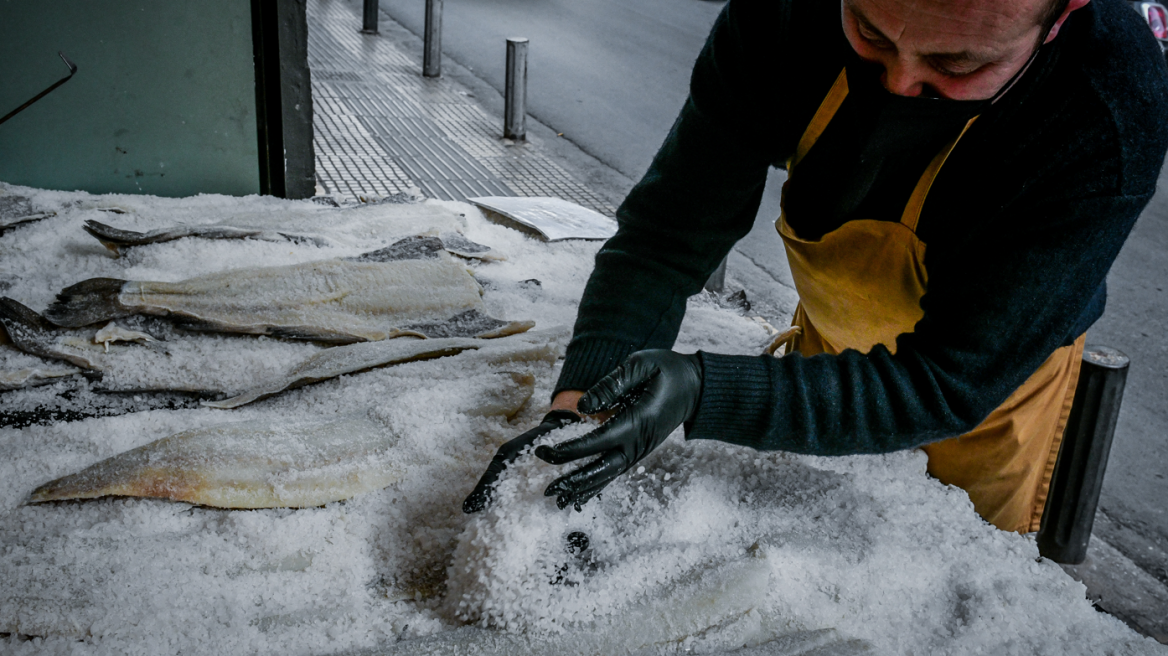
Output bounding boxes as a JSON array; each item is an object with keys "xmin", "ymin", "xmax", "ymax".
[{"xmin": 0, "ymin": 0, "xmax": 259, "ymax": 196}]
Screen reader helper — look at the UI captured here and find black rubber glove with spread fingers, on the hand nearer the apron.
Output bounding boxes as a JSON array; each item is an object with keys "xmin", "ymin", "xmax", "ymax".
[{"xmin": 535, "ymin": 349, "xmax": 702, "ymax": 510}]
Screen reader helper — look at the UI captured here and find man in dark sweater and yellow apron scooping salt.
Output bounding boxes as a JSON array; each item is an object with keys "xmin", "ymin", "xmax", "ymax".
[{"xmin": 464, "ymin": 0, "xmax": 1168, "ymax": 532}]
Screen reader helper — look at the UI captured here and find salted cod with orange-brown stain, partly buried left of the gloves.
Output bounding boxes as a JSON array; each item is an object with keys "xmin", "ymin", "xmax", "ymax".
[{"xmin": 29, "ymin": 372, "xmax": 535, "ymax": 509}]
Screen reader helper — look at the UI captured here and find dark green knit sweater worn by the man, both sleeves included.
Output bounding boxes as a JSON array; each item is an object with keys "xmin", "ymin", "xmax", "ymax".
[{"xmin": 556, "ymin": 0, "xmax": 1168, "ymax": 455}]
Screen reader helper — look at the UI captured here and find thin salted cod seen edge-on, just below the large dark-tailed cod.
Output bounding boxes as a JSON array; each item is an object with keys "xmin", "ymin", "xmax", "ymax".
[{"xmin": 203, "ymin": 329, "xmax": 569, "ymax": 410}]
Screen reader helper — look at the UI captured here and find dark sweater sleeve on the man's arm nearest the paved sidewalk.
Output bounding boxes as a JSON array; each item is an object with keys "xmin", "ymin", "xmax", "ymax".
[{"xmin": 556, "ymin": 0, "xmax": 793, "ymax": 393}]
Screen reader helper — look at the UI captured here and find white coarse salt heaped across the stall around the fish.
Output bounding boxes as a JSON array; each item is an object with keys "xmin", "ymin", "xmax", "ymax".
[{"xmin": 0, "ymin": 179, "xmax": 1164, "ymax": 655}]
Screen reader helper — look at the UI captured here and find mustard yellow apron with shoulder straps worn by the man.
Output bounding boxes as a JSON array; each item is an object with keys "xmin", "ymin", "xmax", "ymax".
[{"xmin": 777, "ymin": 70, "xmax": 1084, "ymax": 532}]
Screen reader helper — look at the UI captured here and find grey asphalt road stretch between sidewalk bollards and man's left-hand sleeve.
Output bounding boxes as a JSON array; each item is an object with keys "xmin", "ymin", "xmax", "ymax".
[{"xmin": 381, "ymin": 0, "xmax": 722, "ymax": 177}]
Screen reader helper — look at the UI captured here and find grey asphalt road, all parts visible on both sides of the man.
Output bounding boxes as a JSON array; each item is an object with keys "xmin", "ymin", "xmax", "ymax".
[{"xmin": 382, "ymin": 0, "xmax": 1168, "ymax": 585}]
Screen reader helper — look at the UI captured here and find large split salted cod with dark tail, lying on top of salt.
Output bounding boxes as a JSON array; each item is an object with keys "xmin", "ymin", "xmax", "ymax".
[{"xmin": 44, "ymin": 246, "xmax": 534, "ymax": 343}]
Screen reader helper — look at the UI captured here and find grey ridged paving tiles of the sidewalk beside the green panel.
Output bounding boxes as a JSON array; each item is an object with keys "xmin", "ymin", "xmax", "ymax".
[{"xmin": 307, "ymin": 0, "xmax": 616, "ymax": 216}]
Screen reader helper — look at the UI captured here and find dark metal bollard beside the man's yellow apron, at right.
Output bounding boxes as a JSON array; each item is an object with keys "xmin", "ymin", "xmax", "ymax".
[{"xmin": 1037, "ymin": 344, "xmax": 1129, "ymax": 565}]
